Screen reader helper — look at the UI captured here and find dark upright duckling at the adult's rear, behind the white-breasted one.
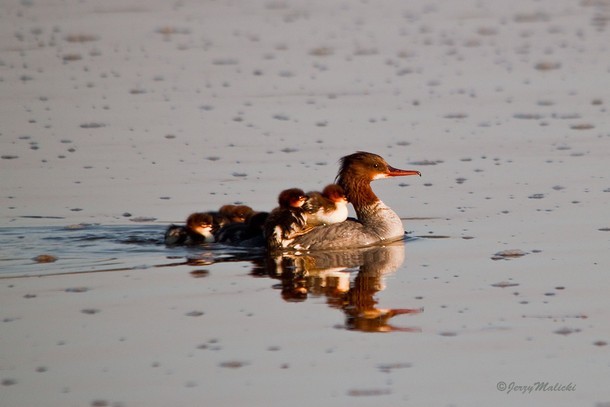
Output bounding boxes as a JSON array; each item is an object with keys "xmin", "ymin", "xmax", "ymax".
[{"xmin": 264, "ymin": 188, "xmax": 308, "ymax": 250}]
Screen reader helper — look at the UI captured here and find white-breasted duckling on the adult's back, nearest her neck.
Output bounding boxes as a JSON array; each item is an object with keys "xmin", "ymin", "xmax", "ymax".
[{"xmin": 303, "ymin": 184, "xmax": 347, "ymax": 226}]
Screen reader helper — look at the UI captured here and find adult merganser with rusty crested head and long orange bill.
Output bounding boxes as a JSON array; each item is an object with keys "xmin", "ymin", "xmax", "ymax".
[{"xmin": 279, "ymin": 151, "xmax": 421, "ymax": 250}]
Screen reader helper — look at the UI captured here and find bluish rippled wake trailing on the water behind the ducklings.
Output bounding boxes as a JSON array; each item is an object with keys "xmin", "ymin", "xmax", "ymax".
[{"xmin": 0, "ymin": 223, "xmax": 261, "ymax": 278}]
